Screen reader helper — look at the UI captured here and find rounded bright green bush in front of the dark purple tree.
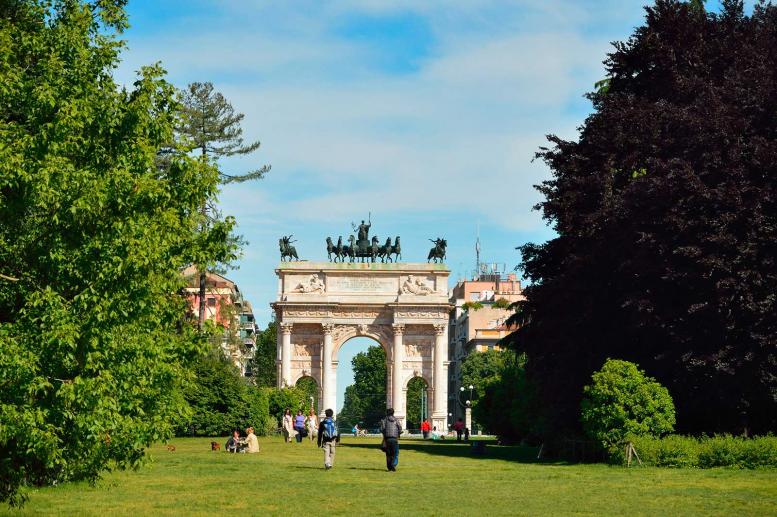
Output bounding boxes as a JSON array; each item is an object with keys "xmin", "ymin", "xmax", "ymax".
[{"xmin": 581, "ymin": 359, "xmax": 675, "ymax": 449}]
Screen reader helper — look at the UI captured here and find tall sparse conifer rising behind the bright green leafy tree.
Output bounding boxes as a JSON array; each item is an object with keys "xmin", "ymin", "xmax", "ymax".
[{"xmin": 177, "ymin": 82, "xmax": 270, "ymax": 330}]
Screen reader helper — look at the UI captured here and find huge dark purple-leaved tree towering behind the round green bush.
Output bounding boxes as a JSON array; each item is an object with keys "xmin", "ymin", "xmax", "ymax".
[{"xmin": 510, "ymin": 0, "xmax": 777, "ymax": 434}]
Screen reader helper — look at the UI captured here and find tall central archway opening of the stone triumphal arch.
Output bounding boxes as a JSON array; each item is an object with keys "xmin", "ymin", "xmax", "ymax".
[{"xmin": 337, "ymin": 336, "xmax": 387, "ymax": 433}]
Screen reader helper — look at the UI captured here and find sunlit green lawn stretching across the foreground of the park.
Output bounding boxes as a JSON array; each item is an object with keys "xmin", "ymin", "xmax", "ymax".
[{"xmin": 6, "ymin": 437, "xmax": 777, "ymax": 517}]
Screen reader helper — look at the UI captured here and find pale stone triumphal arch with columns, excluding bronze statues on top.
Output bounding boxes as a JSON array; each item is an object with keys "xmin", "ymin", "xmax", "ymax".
[{"xmin": 272, "ymin": 261, "xmax": 451, "ymax": 429}]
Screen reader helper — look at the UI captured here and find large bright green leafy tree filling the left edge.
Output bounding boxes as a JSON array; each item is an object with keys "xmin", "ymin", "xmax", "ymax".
[{"xmin": 0, "ymin": 0, "xmax": 230, "ymax": 504}]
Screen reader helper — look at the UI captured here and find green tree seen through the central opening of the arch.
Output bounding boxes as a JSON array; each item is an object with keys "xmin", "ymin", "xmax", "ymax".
[{"xmin": 337, "ymin": 346, "xmax": 386, "ymax": 428}]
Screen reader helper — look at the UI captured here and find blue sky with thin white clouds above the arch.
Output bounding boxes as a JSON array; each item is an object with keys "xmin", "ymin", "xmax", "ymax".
[{"xmin": 116, "ymin": 0, "xmax": 740, "ymax": 412}]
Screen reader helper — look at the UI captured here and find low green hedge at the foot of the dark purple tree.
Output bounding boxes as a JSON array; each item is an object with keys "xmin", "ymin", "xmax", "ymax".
[{"xmin": 610, "ymin": 435, "xmax": 777, "ymax": 469}]
